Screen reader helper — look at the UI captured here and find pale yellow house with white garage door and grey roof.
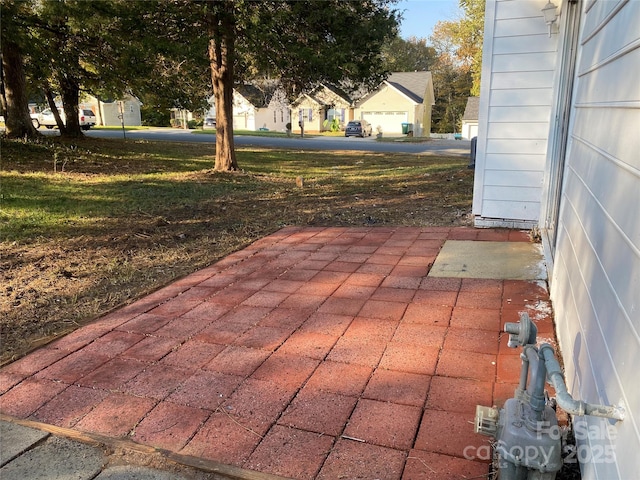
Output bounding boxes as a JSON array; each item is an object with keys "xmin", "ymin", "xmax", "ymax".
[{"xmin": 354, "ymin": 72, "xmax": 435, "ymax": 136}]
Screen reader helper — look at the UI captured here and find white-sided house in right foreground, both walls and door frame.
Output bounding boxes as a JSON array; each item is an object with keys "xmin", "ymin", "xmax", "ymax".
[{"xmin": 473, "ymin": 0, "xmax": 640, "ymax": 480}]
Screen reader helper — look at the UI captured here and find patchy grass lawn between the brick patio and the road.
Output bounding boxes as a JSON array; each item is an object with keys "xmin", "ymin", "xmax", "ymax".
[{"xmin": 0, "ymin": 133, "xmax": 473, "ymax": 363}]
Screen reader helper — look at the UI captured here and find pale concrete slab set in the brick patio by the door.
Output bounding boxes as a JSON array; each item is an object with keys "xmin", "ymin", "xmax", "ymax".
[{"xmin": 428, "ymin": 240, "xmax": 547, "ymax": 280}]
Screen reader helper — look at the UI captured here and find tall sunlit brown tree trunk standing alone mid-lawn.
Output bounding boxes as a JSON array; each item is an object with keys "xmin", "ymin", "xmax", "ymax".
[{"xmin": 208, "ymin": 1, "xmax": 238, "ymax": 171}]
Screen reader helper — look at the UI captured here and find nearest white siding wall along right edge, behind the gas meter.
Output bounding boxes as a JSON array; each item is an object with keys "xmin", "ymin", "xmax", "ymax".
[{"xmin": 551, "ymin": 0, "xmax": 640, "ymax": 480}]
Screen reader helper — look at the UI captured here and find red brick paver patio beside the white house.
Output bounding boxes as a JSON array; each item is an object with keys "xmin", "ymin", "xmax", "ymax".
[{"xmin": 0, "ymin": 228, "xmax": 553, "ymax": 480}]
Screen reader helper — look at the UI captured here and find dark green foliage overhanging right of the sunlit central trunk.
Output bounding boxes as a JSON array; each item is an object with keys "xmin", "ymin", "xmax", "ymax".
[{"xmin": 236, "ymin": 0, "xmax": 398, "ymax": 96}]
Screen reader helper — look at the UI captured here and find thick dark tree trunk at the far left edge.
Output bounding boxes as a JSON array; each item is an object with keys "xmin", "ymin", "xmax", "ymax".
[{"xmin": 2, "ymin": 39, "xmax": 39, "ymax": 138}]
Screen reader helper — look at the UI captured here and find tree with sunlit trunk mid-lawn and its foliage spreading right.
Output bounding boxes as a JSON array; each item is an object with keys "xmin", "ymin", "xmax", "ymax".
[{"xmin": 204, "ymin": 0, "xmax": 398, "ymax": 170}]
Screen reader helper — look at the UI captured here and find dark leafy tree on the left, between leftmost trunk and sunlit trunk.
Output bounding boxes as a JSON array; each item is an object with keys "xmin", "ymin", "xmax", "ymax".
[{"xmin": 14, "ymin": 0, "xmax": 211, "ymax": 137}]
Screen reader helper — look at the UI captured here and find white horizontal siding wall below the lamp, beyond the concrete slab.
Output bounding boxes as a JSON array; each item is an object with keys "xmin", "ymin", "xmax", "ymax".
[{"xmin": 473, "ymin": 0, "xmax": 558, "ymax": 228}]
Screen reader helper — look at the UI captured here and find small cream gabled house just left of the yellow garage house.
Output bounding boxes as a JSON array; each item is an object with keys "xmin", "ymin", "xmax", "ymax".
[{"xmin": 291, "ymin": 84, "xmax": 351, "ymax": 133}]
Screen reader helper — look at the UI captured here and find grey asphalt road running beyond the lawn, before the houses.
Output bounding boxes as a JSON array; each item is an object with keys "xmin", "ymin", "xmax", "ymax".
[{"xmin": 76, "ymin": 128, "xmax": 470, "ymax": 157}]
